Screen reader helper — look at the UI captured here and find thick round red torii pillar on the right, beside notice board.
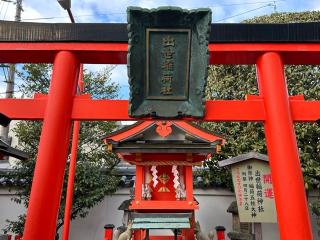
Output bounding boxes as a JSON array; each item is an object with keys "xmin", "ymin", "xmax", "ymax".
[{"xmin": 257, "ymin": 52, "xmax": 312, "ymax": 240}]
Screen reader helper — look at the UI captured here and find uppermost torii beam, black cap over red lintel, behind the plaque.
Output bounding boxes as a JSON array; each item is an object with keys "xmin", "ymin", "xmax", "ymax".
[{"xmin": 0, "ymin": 21, "xmax": 320, "ymax": 64}]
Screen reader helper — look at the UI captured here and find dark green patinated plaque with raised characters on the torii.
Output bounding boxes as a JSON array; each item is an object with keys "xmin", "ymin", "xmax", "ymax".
[{"xmin": 127, "ymin": 7, "xmax": 211, "ymax": 118}]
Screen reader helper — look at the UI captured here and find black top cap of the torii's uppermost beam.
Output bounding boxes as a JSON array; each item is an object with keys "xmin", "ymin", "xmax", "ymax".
[{"xmin": 0, "ymin": 21, "xmax": 320, "ymax": 43}]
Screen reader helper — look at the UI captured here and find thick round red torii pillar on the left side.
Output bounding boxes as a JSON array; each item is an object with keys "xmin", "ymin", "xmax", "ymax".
[{"xmin": 23, "ymin": 51, "xmax": 79, "ymax": 240}]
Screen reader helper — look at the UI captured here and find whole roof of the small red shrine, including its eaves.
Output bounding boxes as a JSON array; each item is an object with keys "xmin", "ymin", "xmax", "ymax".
[{"xmin": 103, "ymin": 120, "xmax": 225, "ymax": 158}]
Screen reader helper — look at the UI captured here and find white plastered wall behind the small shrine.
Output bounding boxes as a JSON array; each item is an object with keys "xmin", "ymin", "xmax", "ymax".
[{"xmin": 0, "ymin": 189, "xmax": 319, "ymax": 240}]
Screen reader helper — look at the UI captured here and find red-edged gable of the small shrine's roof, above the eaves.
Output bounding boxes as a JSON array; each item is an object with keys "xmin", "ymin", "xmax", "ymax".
[{"xmin": 103, "ymin": 120, "xmax": 224, "ymax": 144}]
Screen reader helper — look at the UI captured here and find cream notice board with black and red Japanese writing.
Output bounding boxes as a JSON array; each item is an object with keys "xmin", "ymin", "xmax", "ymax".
[{"xmin": 231, "ymin": 160, "xmax": 277, "ymax": 223}]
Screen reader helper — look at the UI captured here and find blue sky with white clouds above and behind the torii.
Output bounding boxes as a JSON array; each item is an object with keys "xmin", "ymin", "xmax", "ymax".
[{"xmin": 0, "ymin": 0, "xmax": 320, "ymax": 99}]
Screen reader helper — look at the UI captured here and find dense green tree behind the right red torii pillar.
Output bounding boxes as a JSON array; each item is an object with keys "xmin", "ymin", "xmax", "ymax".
[{"xmin": 203, "ymin": 12, "xmax": 320, "ymax": 202}]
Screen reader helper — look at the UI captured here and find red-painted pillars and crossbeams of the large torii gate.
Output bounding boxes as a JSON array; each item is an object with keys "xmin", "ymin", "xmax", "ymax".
[{"xmin": 0, "ymin": 23, "xmax": 320, "ymax": 240}]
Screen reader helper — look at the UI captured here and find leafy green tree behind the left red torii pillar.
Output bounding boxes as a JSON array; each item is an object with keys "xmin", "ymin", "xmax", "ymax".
[{"xmin": 1, "ymin": 64, "xmax": 119, "ymax": 233}]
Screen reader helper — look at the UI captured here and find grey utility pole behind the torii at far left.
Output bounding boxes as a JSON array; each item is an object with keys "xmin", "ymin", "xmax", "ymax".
[{"xmin": 1, "ymin": 0, "xmax": 22, "ymax": 145}]
